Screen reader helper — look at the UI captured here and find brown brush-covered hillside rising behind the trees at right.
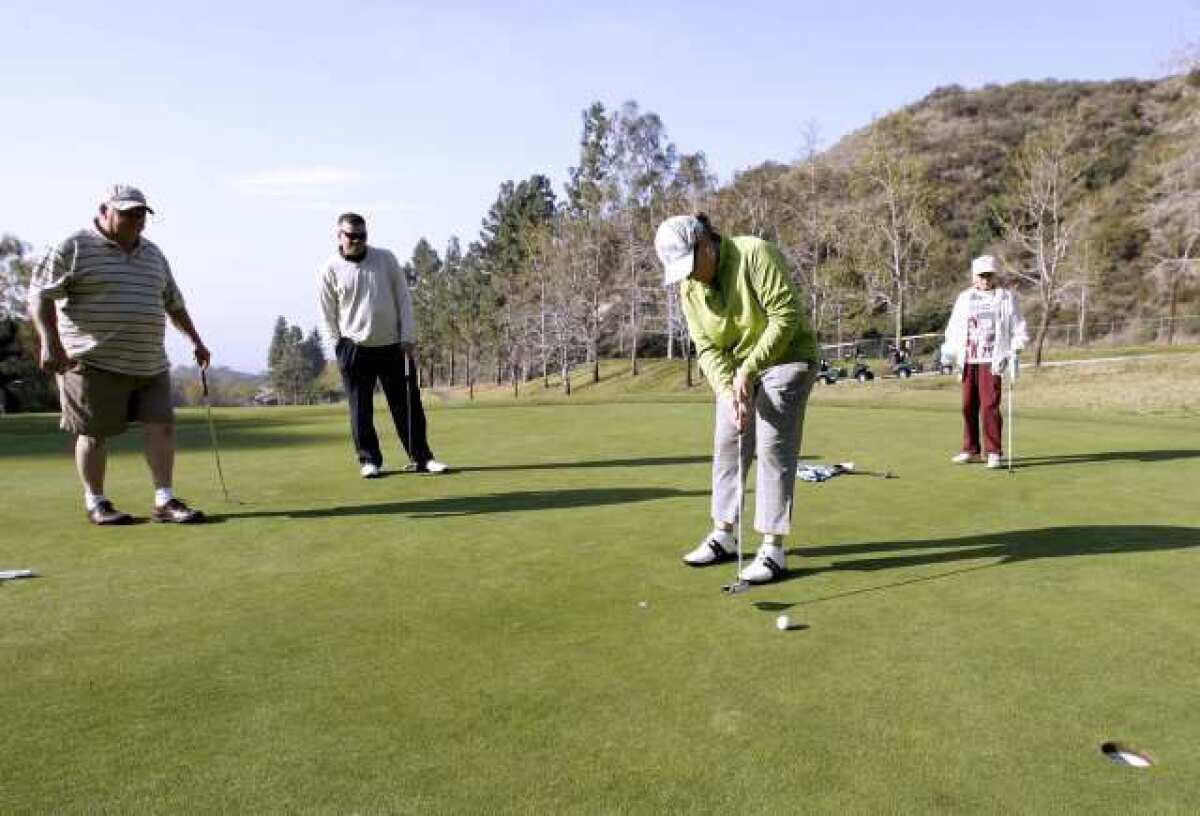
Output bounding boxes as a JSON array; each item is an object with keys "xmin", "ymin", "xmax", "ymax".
[{"xmin": 721, "ymin": 71, "xmax": 1200, "ymax": 331}]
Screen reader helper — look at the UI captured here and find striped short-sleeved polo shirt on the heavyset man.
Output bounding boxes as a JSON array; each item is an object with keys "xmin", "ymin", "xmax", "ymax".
[{"xmin": 30, "ymin": 224, "xmax": 184, "ymax": 377}]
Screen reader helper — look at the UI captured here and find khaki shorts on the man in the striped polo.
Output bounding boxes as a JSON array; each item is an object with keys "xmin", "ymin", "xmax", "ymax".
[{"xmin": 58, "ymin": 365, "xmax": 175, "ymax": 439}]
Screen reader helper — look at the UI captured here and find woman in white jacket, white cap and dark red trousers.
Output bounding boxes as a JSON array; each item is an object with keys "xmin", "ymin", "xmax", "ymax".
[{"xmin": 942, "ymin": 256, "xmax": 1028, "ymax": 468}]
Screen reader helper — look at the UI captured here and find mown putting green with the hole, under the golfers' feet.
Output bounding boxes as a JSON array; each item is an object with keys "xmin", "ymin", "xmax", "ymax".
[{"xmin": 0, "ymin": 398, "xmax": 1200, "ymax": 814}]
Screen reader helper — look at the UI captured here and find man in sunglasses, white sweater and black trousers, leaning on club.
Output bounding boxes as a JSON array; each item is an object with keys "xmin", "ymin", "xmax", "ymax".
[{"xmin": 319, "ymin": 212, "xmax": 446, "ymax": 479}]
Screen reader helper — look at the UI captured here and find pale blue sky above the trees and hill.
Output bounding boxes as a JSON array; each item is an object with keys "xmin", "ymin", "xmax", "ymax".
[{"xmin": 0, "ymin": 0, "xmax": 1200, "ymax": 371}]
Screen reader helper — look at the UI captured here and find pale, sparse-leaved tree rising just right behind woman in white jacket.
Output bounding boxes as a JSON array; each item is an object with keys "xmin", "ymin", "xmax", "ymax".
[{"xmin": 1000, "ymin": 119, "xmax": 1086, "ymax": 365}]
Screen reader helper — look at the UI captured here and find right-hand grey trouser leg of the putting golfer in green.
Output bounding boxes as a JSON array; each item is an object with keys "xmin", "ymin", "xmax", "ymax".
[{"xmin": 754, "ymin": 362, "xmax": 816, "ymax": 535}]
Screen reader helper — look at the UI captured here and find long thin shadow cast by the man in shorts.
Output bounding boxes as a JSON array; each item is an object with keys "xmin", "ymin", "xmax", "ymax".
[{"xmin": 212, "ymin": 487, "xmax": 708, "ymax": 522}]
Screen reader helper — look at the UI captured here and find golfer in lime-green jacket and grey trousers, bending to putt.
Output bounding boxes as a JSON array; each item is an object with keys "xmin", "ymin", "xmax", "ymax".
[{"xmin": 654, "ymin": 215, "xmax": 817, "ymax": 583}]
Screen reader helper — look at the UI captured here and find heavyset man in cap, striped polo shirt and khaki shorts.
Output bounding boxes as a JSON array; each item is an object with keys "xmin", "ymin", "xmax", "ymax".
[{"xmin": 30, "ymin": 185, "xmax": 209, "ymax": 524}]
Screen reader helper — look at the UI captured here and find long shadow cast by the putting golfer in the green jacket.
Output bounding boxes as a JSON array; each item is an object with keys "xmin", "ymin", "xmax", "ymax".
[{"xmin": 784, "ymin": 524, "xmax": 1200, "ymax": 605}]
